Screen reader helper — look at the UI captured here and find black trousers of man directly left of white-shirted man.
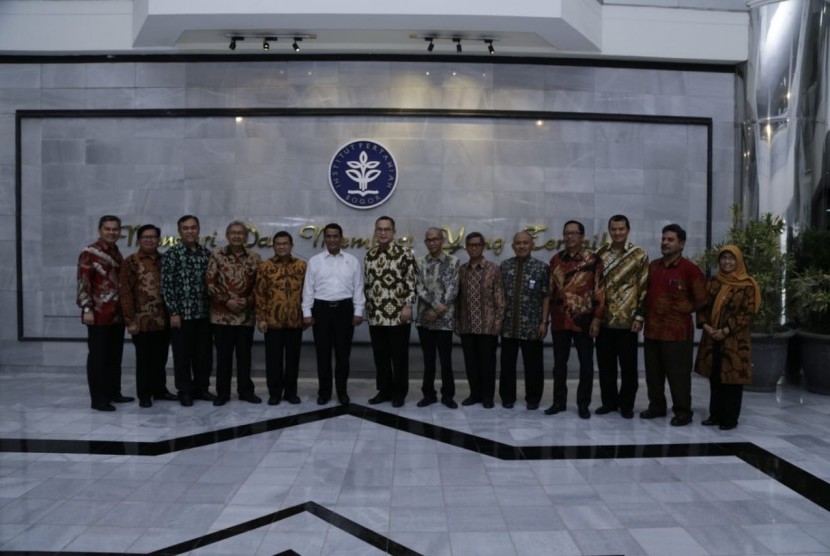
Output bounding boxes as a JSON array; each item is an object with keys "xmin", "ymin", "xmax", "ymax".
[{"xmin": 265, "ymin": 328, "xmax": 303, "ymax": 398}]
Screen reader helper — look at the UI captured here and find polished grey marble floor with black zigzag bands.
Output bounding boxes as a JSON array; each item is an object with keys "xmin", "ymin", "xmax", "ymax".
[{"xmin": 0, "ymin": 369, "xmax": 830, "ymax": 556}]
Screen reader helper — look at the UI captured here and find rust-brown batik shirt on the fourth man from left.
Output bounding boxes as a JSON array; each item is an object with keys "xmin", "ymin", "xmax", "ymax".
[{"xmin": 206, "ymin": 247, "xmax": 262, "ymax": 326}]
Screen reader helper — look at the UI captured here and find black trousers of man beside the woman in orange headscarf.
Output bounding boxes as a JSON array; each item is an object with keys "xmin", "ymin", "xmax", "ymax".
[{"xmin": 644, "ymin": 339, "xmax": 693, "ymax": 418}]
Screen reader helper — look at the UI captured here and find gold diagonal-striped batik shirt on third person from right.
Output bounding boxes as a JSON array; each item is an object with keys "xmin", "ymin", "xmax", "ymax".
[{"xmin": 597, "ymin": 242, "xmax": 648, "ymax": 329}]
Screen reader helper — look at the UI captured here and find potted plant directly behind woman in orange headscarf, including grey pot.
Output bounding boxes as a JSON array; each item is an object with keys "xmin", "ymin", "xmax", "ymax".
[{"xmin": 697, "ymin": 205, "xmax": 795, "ymax": 392}]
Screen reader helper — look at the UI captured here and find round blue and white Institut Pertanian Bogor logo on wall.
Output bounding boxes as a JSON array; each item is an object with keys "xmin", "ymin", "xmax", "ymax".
[{"xmin": 329, "ymin": 139, "xmax": 398, "ymax": 209}]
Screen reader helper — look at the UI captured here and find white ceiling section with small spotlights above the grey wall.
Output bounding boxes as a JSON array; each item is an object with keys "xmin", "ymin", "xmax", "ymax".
[{"xmin": 0, "ymin": 0, "xmax": 748, "ymax": 63}]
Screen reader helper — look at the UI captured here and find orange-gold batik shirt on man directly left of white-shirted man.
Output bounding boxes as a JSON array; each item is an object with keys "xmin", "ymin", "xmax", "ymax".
[{"xmin": 254, "ymin": 256, "xmax": 307, "ymax": 328}]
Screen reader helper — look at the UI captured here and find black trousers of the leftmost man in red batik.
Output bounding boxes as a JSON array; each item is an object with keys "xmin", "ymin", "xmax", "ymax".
[{"xmin": 86, "ymin": 324, "xmax": 124, "ymax": 405}]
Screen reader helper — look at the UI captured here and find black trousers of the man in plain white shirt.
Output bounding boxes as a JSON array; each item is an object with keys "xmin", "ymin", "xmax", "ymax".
[{"xmin": 311, "ymin": 299, "xmax": 354, "ymax": 400}]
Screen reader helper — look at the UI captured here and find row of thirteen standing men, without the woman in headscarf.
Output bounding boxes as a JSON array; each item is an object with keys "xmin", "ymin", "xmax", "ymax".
[{"xmin": 78, "ymin": 215, "xmax": 706, "ymax": 426}]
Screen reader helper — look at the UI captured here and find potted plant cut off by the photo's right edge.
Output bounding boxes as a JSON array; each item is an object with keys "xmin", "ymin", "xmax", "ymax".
[{"xmin": 790, "ymin": 230, "xmax": 830, "ymax": 394}]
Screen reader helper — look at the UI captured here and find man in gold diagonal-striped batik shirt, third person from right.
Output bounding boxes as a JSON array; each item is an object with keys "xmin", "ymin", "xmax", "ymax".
[{"xmin": 594, "ymin": 214, "xmax": 648, "ymax": 419}]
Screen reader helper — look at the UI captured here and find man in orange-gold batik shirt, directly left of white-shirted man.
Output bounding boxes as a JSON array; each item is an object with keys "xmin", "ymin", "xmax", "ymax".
[{"xmin": 254, "ymin": 231, "xmax": 306, "ymax": 405}]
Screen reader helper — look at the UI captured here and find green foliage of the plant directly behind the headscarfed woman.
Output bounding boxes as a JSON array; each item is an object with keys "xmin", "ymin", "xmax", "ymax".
[{"xmin": 696, "ymin": 205, "xmax": 794, "ymax": 334}]
